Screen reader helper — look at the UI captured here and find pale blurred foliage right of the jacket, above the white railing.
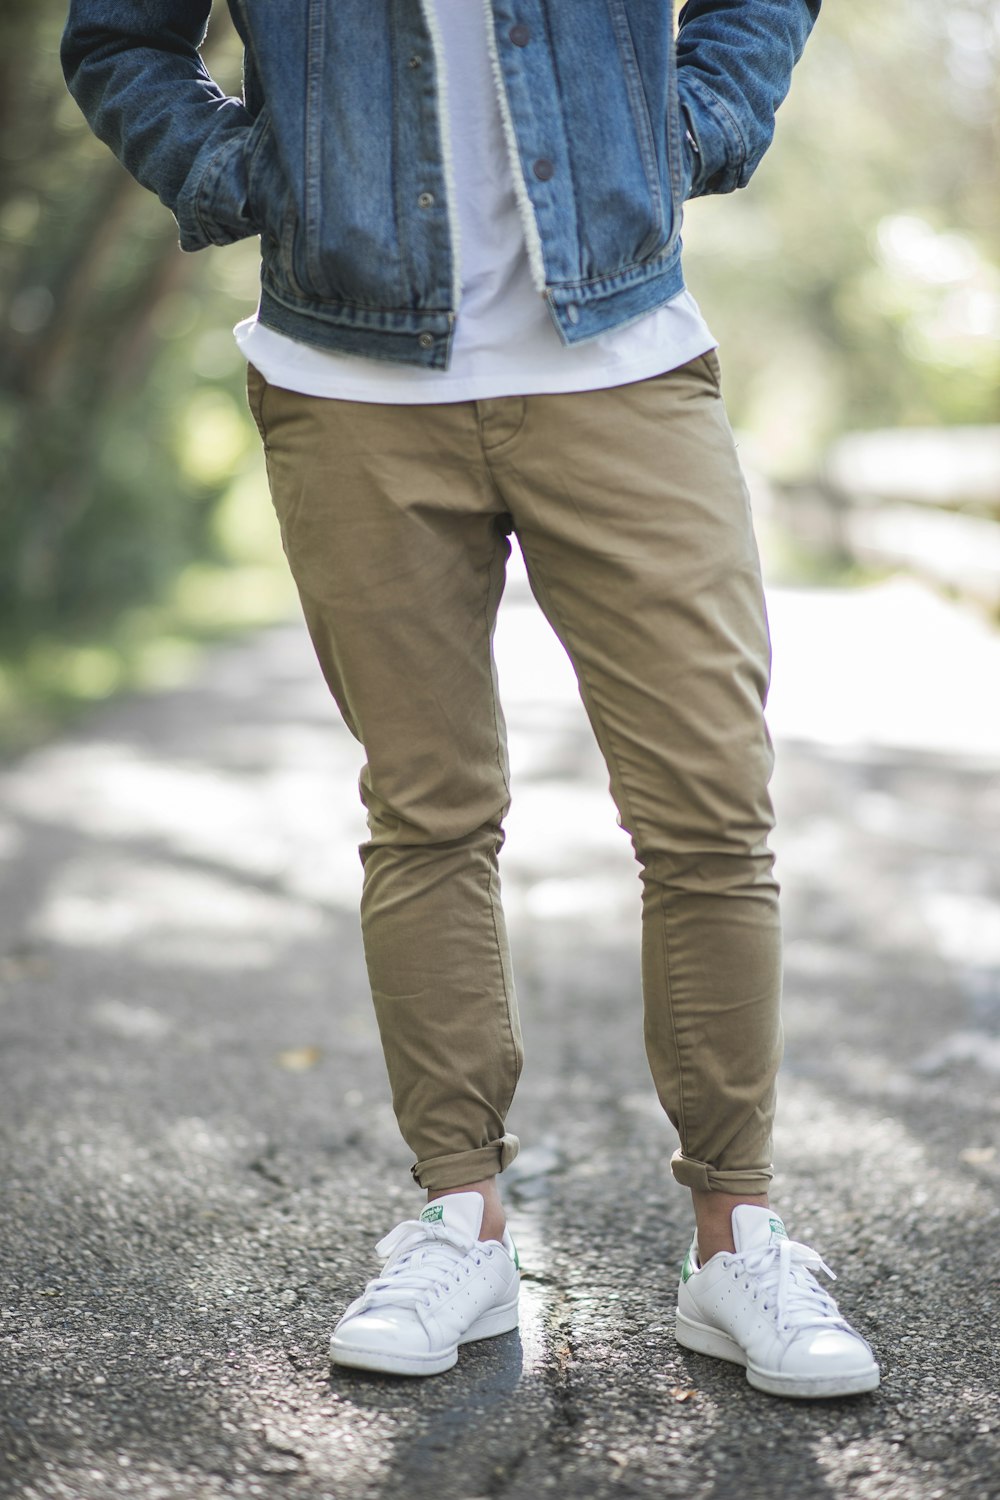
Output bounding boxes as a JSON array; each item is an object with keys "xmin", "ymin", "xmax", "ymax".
[{"xmin": 685, "ymin": 0, "xmax": 1000, "ymax": 479}]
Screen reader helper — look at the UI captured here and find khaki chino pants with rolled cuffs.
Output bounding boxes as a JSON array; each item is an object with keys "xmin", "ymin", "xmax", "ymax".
[{"xmin": 249, "ymin": 354, "xmax": 781, "ymax": 1194}]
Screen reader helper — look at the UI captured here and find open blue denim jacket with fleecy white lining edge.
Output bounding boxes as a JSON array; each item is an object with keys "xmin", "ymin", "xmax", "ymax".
[{"xmin": 61, "ymin": 0, "xmax": 820, "ymax": 369}]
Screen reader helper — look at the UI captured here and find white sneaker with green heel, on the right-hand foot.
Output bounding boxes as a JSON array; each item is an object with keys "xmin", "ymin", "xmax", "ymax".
[{"xmin": 676, "ymin": 1203, "xmax": 879, "ymax": 1397}]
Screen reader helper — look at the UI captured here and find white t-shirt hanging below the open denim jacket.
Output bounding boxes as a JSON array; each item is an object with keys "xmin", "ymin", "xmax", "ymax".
[{"xmin": 234, "ymin": 0, "xmax": 715, "ymax": 405}]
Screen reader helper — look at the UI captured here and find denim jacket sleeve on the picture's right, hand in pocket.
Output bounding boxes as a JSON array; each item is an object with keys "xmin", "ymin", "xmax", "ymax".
[{"xmin": 678, "ymin": 0, "xmax": 820, "ymax": 198}]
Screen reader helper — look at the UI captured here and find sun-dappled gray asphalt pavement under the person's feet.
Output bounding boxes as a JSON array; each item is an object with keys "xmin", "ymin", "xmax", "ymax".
[{"xmin": 0, "ymin": 564, "xmax": 1000, "ymax": 1500}]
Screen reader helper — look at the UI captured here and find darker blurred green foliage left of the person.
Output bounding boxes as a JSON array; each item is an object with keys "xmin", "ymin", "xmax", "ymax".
[{"xmin": 0, "ymin": 0, "xmax": 292, "ymax": 749}]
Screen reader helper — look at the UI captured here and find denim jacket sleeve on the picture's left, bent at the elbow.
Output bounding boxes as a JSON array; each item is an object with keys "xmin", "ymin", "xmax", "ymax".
[{"xmin": 61, "ymin": 0, "xmax": 256, "ymax": 251}]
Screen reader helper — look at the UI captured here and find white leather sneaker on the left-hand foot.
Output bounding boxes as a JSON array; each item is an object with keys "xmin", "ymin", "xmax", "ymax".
[{"xmin": 330, "ymin": 1193, "xmax": 520, "ymax": 1376}]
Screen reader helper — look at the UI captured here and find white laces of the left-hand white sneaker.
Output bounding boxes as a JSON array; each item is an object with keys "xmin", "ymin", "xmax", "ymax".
[{"xmin": 352, "ymin": 1220, "xmax": 493, "ymax": 1320}]
